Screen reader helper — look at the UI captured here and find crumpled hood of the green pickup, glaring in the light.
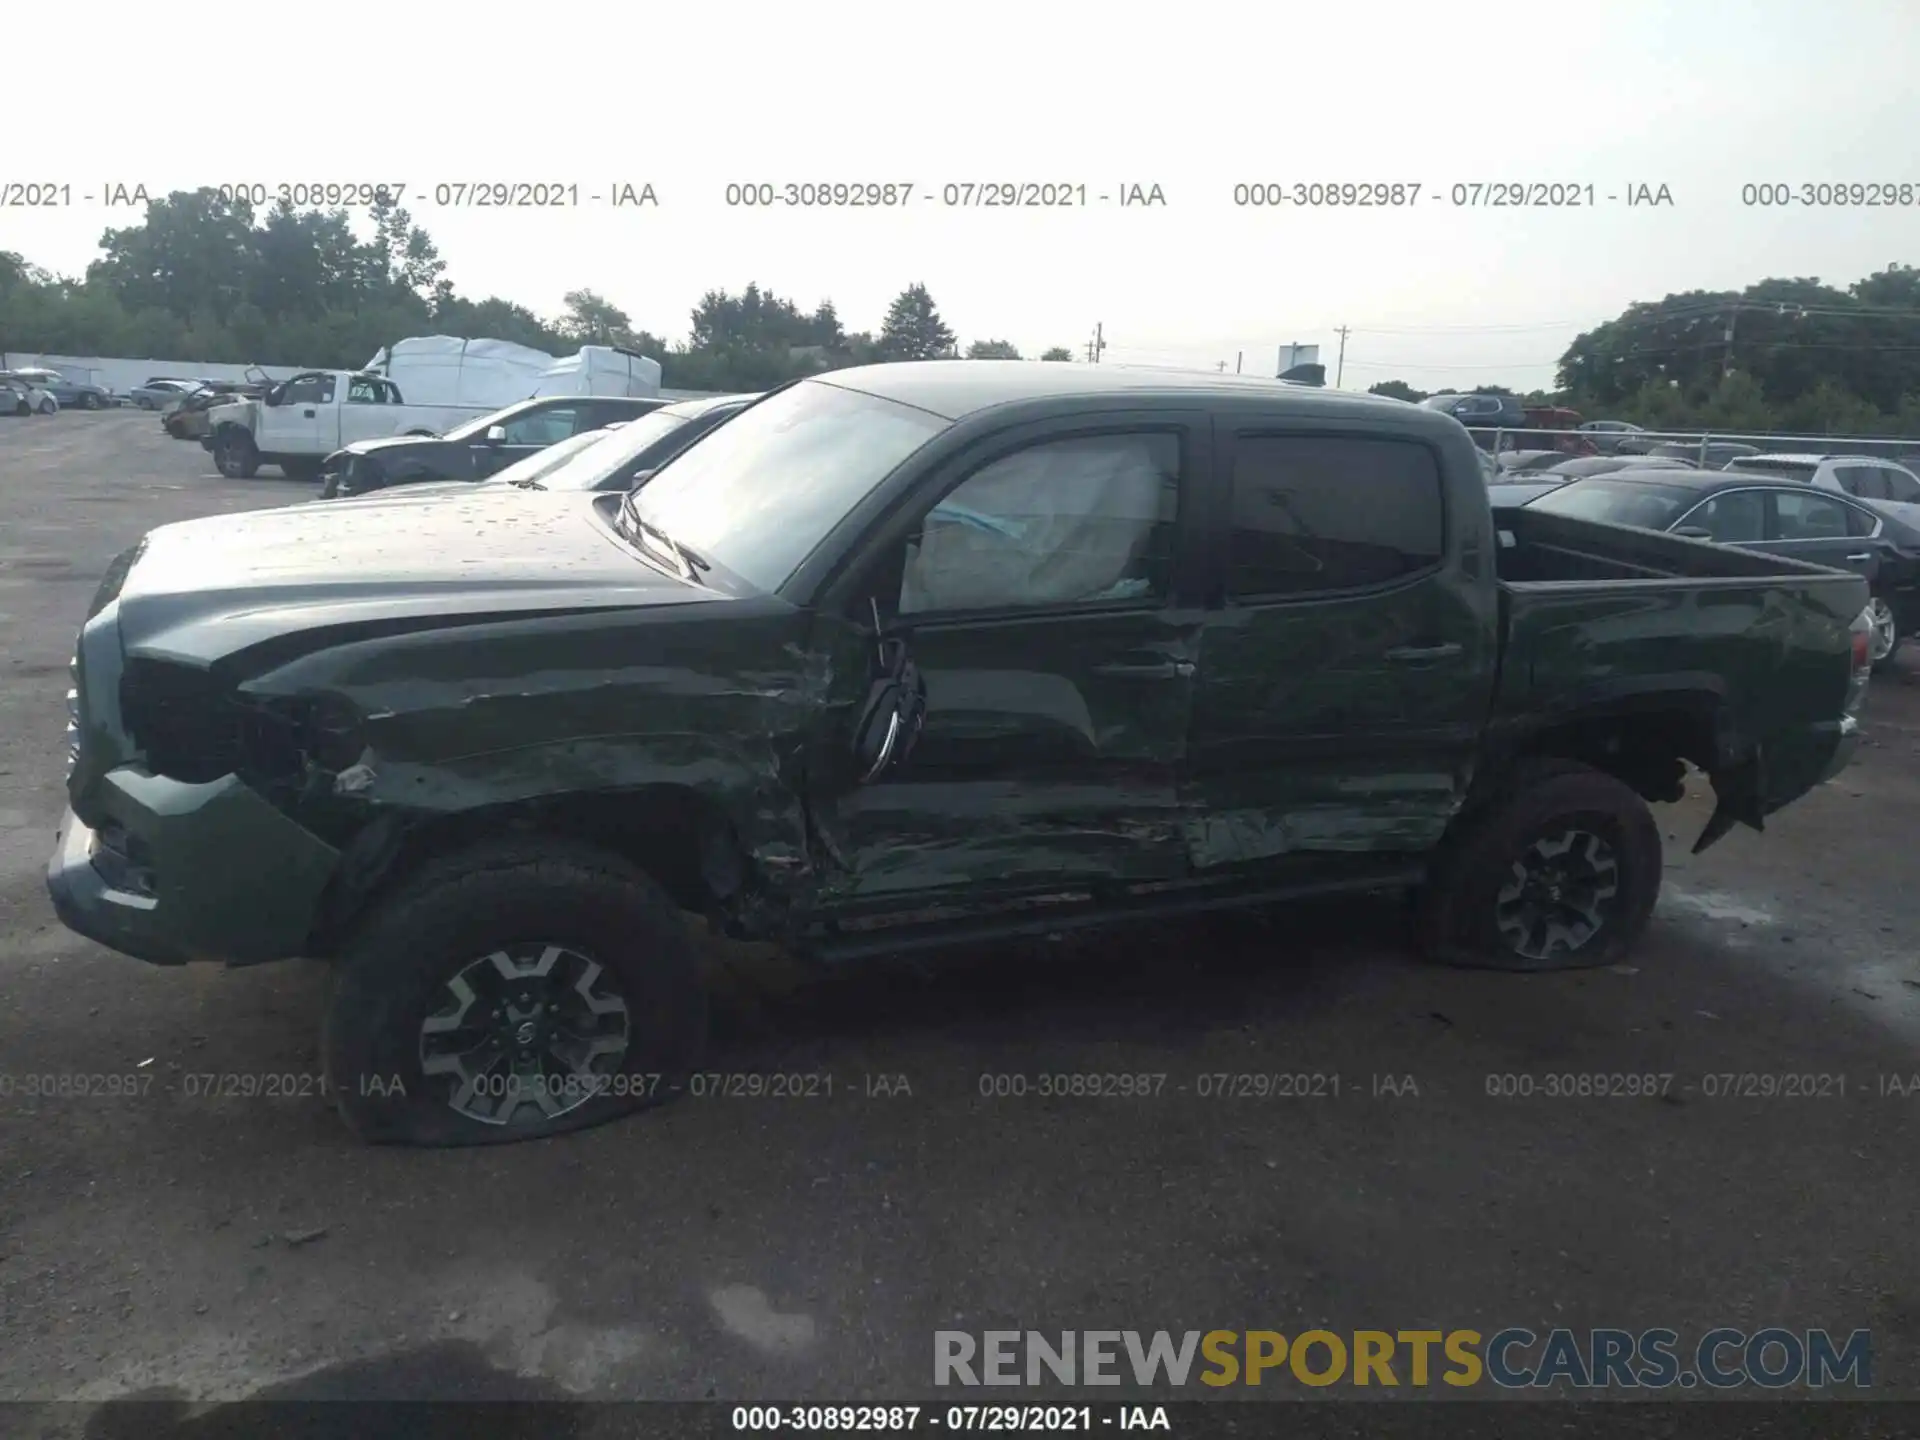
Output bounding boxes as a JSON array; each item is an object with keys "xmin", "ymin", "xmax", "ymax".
[{"xmin": 99, "ymin": 486, "xmax": 726, "ymax": 664}]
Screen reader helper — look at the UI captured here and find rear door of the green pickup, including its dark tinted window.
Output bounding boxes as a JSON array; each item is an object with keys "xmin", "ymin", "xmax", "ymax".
[{"xmin": 1188, "ymin": 420, "xmax": 1498, "ymax": 870}]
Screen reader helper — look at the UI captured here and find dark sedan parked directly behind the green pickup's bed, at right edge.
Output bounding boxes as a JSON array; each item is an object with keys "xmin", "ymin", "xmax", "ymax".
[{"xmin": 1528, "ymin": 470, "xmax": 1920, "ymax": 668}]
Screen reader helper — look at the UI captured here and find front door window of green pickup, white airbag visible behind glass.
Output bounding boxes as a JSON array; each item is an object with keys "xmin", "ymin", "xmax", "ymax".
[{"xmin": 899, "ymin": 432, "xmax": 1181, "ymax": 614}]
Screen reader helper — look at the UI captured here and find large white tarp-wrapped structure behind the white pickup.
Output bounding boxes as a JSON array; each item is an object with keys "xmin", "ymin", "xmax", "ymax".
[{"xmin": 367, "ymin": 334, "xmax": 660, "ymax": 409}]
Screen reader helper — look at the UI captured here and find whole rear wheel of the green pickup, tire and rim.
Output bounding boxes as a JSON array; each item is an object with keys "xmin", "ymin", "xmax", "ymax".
[{"xmin": 1419, "ymin": 762, "xmax": 1663, "ymax": 972}]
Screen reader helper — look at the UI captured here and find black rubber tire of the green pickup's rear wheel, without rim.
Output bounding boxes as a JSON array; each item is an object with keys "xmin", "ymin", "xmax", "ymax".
[{"xmin": 1415, "ymin": 760, "xmax": 1663, "ymax": 972}]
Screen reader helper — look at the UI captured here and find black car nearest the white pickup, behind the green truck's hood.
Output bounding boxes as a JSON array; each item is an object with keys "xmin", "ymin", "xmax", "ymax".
[{"xmin": 321, "ymin": 396, "xmax": 666, "ymax": 499}]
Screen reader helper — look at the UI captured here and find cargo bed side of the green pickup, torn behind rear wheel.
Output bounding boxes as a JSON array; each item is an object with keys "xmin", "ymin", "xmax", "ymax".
[{"xmin": 1494, "ymin": 509, "xmax": 1868, "ymax": 824}]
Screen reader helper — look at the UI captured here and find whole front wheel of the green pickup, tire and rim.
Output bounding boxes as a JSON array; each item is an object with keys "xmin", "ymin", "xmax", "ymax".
[{"xmin": 321, "ymin": 839, "xmax": 707, "ymax": 1144}]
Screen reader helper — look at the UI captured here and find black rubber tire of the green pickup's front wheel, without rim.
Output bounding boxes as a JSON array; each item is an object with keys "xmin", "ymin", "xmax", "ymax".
[{"xmin": 321, "ymin": 837, "xmax": 708, "ymax": 1146}]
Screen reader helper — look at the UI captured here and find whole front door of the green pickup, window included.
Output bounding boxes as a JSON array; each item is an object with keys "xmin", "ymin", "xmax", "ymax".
[{"xmin": 816, "ymin": 413, "xmax": 1208, "ymax": 910}]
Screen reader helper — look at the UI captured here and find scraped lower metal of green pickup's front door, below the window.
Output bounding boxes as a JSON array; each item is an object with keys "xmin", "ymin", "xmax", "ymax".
[{"xmin": 818, "ymin": 611, "xmax": 1200, "ymax": 904}]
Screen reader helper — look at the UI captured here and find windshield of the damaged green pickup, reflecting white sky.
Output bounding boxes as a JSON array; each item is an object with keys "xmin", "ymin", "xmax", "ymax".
[{"xmin": 636, "ymin": 380, "xmax": 950, "ymax": 589}]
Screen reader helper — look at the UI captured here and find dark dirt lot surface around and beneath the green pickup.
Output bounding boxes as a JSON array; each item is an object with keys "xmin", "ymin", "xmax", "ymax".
[{"xmin": 0, "ymin": 413, "xmax": 1920, "ymax": 1400}]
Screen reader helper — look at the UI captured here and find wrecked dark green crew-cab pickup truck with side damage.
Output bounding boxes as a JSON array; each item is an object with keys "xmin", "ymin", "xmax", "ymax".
[{"xmin": 48, "ymin": 361, "xmax": 1868, "ymax": 1144}]
